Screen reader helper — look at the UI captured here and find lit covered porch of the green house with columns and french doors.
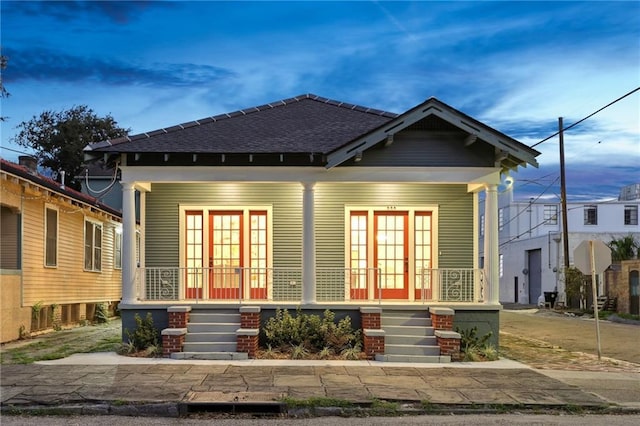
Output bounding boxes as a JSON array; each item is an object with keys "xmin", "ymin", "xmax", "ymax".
[{"xmin": 117, "ymin": 173, "xmax": 499, "ymax": 307}]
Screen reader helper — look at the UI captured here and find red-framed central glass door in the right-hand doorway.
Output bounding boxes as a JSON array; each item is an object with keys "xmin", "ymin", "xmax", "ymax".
[{"xmin": 373, "ymin": 211, "xmax": 409, "ymax": 300}]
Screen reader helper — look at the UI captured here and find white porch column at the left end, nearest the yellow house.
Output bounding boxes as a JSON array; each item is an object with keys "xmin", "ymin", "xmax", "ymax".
[{"xmin": 121, "ymin": 182, "xmax": 137, "ymax": 303}]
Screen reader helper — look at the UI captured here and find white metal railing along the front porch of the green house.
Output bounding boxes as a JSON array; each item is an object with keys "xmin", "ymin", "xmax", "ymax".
[{"xmin": 136, "ymin": 267, "xmax": 485, "ymax": 303}]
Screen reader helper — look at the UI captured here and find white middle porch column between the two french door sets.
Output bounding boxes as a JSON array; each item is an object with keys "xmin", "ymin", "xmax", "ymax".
[{"xmin": 302, "ymin": 182, "xmax": 316, "ymax": 304}]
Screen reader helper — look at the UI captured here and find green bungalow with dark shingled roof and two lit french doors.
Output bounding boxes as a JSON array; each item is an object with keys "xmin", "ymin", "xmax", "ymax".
[{"xmin": 85, "ymin": 94, "xmax": 539, "ymax": 362}]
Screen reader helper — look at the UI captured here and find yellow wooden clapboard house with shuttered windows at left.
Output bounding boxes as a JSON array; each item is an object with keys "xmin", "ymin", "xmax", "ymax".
[{"xmin": 0, "ymin": 157, "xmax": 122, "ymax": 342}]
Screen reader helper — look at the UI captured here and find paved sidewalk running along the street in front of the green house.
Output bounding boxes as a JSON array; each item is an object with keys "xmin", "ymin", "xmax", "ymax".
[{"xmin": 0, "ymin": 353, "xmax": 640, "ymax": 416}]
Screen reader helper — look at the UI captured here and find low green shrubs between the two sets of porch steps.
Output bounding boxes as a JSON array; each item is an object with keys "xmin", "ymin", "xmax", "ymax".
[{"xmin": 260, "ymin": 308, "xmax": 363, "ymax": 359}]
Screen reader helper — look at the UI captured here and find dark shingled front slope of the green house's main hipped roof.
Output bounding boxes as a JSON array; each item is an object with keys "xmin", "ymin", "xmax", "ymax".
[{"xmin": 91, "ymin": 94, "xmax": 398, "ymax": 154}]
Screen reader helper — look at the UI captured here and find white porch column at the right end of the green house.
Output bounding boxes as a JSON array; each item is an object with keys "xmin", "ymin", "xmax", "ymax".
[{"xmin": 484, "ymin": 185, "xmax": 500, "ymax": 305}]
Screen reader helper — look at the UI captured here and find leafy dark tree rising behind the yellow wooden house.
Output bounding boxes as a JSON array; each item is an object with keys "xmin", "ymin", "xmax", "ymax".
[{"xmin": 15, "ymin": 105, "xmax": 130, "ymax": 190}]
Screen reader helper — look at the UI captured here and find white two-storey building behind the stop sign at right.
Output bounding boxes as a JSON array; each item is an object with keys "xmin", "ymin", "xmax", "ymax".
[{"xmin": 480, "ymin": 186, "xmax": 640, "ymax": 304}]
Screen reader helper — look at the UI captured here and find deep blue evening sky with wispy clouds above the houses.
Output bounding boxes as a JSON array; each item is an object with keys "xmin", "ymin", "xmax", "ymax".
[{"xmin": 0, "ymin": 0, "xmax": 640, "ymax": 201}]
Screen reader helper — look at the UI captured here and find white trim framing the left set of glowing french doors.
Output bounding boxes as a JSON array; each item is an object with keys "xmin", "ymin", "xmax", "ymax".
[{"xmin": 178, "ymin": 204, "xmax": 273, "ymax": 300}]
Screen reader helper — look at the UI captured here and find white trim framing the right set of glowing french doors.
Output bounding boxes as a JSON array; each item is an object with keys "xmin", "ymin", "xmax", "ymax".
[{"xmin": 344, "ymin": 204, "xmax": 440, "ymax": 301}]
